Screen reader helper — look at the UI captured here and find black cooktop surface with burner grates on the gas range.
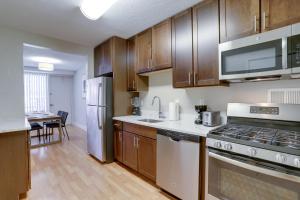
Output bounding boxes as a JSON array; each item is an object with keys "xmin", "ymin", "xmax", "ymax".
[{"xmin": 208, "ymin": 124, "xmax": 300, "ymax": 155}]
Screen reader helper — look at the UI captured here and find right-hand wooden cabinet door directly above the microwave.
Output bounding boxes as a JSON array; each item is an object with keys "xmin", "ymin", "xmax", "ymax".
[{"xmin": 261, "ymin": 0, "xmax": 300, "ymax": 31}]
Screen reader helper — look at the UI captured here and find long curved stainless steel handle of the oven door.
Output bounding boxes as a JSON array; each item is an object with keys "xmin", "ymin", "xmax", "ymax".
[{"xmin": 208, "ymin": 152, "xmax": 300, "ymax": 183}]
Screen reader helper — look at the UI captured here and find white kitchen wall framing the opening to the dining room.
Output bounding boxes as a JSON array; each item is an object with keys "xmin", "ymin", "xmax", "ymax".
[{"xmin": 0, "ymin": 26, "xmax": 94, "ymax": 120}]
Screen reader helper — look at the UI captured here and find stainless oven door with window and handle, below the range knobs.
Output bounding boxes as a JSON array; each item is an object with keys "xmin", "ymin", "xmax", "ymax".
[{"xmin": 207, "ymin": 149, "xmax": 300, "ymax": 200}]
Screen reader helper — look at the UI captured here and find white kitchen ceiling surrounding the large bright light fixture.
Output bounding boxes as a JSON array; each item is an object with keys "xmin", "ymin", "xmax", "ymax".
[{"xmin": 0, "ymin": 0, "xmax": 201, "ymax": 46}]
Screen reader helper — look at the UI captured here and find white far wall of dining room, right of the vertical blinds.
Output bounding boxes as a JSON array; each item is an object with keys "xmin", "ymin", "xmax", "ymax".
[{"xmin": 49, "ymin": 74, "xmax": 73, "ymax": 124}]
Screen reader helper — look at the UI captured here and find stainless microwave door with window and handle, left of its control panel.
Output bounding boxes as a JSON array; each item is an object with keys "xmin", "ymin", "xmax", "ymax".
[{"xmin": 219, "ymin": 26, "xmax": 291, "ymax": 80}]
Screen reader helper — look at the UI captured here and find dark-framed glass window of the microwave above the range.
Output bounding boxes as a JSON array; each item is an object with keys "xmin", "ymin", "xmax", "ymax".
[{"xmin": 222, "ymin": 39, "xmax": 283, "ymax": 75}]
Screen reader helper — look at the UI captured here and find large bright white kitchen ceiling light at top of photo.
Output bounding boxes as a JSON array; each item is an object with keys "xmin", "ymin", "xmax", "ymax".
[{"xmin": 80, "ymin": 0, "xmax": 117, "ymax": 20}]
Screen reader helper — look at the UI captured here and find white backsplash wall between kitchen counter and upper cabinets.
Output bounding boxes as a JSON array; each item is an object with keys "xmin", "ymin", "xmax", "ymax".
[{"xmin": 140, "ymin": 72, "xmax": 300, "ymax": 114}]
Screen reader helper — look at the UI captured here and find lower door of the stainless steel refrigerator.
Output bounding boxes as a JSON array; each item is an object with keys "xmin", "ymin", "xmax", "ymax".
[{"xmin": 87, "ymin": 106, "xmax": 106, "ymax": 162}]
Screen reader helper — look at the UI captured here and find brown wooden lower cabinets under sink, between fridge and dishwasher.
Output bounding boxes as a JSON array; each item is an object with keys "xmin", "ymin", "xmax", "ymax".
[{"xmin": 114, "ymin": 122, "xmax": 156, "ymax": 181}]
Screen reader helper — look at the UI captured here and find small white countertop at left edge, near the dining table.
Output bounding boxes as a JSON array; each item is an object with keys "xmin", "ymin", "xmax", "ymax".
[{"xmin": 0, "ymin": 117, "xmax": 31, "ymax": 134}]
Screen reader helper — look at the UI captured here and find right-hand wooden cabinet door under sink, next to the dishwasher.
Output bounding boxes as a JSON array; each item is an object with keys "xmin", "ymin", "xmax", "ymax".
[{"xmin": 137, "ymin": 136, "xmax": 156, "ymax": 181}]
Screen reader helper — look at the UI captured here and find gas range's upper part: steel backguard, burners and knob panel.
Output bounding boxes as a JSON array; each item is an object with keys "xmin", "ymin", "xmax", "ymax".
[{"xmin": 207, "ymin": 104, "xmax": 300, "ymax": 168}]
